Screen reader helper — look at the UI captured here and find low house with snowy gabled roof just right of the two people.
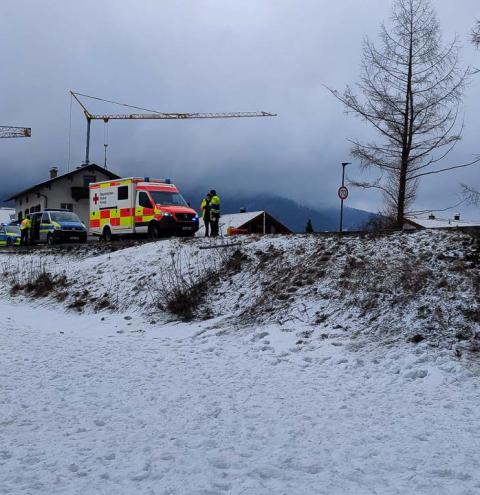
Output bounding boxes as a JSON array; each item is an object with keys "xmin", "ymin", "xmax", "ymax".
[{"xmin": 197, "ymin": 211, "xmax": 292, "ymax": 237}]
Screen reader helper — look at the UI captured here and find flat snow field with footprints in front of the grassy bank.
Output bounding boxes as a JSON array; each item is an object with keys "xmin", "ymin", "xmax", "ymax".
[{"xmin": 0, "ymin": 303, "xmax": 480, "ymax": 495}]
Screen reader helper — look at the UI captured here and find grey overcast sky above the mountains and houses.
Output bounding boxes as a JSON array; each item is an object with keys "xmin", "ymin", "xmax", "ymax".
[{"xmin": 0, "ymin": 0, "xmax": 480, "ymax": 217}]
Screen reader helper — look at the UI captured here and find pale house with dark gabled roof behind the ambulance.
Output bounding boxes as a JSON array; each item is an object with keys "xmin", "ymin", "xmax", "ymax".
[{"xmin": 6, "ymin": 164, "xmax": 119, "ymax": 225}]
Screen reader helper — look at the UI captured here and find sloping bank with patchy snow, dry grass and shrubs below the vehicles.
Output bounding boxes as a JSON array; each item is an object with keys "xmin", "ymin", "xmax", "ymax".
[{"xmin": 0, "ymin": 231, "xmax": 480, "ymax": 350}]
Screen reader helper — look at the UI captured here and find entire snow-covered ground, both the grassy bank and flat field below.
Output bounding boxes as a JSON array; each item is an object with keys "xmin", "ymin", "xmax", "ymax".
[{"xmin": 0, "ymin": 232, "xmax": 480, "ymax": 495}]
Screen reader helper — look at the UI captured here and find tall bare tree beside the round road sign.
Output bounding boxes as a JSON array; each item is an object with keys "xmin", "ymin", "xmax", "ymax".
[{"xmin": 330, "ymin": 0, "xmax": 480, "ymax": 227}]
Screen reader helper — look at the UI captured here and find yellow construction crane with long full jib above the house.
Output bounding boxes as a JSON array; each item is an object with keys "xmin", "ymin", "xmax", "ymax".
[{"xmin": 70, "ymin": 91, "xmax": 277, "ymax": 165}]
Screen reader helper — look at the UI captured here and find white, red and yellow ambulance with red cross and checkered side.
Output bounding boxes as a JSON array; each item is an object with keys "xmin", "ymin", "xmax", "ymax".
[{"xmin": 89, "ymin": 177, "xmax": 199, "ymax": 241}]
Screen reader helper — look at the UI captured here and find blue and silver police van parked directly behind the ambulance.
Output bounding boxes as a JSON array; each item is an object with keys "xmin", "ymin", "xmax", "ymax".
[{"xmin": 30, "ymin": 209, "xmax": 87, "ymax": 244}]
